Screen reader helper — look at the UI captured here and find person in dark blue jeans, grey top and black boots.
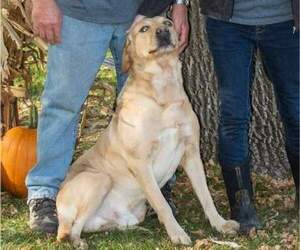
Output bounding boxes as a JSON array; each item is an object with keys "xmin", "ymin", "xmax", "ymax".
[{"xmin": 206, "ymin": 0, "xmax": 299, "ymax": 233}]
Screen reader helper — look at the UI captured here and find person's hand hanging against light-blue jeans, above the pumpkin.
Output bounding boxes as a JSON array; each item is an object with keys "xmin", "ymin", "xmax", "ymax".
[{"xmin": 31, "ymin": 0, "xmax": 62, "ymax": 44}]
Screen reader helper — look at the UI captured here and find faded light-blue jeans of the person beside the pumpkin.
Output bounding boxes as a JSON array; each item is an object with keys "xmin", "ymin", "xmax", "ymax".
[{"xmin": 26, "ymin": 16, "xmax": 130, "ymax": 200}]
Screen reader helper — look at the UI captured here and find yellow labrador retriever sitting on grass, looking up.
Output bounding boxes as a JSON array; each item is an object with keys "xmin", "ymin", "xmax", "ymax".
[{"xmin": 57, "ymin": 17, "xmax": 239, "ymax": 248}]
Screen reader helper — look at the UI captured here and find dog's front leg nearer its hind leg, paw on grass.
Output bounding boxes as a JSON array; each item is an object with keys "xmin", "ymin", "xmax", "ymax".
[{"xmin": 132, "ymin": 160, "xmax": 191, "ymax": 245}]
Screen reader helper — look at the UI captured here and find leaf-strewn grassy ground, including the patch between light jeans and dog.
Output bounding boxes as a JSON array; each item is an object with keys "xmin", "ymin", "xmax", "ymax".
[{"xmin": 1, "ymin": 59, "xmax": 299, "ymax": 250}]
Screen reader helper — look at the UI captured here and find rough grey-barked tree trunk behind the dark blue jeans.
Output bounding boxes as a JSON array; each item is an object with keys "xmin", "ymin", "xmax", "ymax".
[{"xmin": 183, "ymin": 1, "xmax": 288, "ymax": 177}]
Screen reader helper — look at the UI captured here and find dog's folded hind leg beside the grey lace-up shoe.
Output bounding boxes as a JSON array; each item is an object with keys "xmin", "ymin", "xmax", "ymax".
[{"xmin": 57, "ymin": 172, "xmax": 112, "ymax": 249}]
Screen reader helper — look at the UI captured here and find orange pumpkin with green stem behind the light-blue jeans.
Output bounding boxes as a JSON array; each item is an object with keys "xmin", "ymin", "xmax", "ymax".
[{"xmin": 0, "ymin": 105, "xmax": 37, "ymax": 198}]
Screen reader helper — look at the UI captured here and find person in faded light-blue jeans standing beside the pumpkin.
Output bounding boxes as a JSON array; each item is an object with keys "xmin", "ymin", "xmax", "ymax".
[{"xmin": 26, "ymin": 0, "xmax": 190, "ymax": 233}]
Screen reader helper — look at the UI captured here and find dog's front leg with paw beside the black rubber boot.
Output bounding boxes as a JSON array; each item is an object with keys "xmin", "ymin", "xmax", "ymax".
[{"xmin": 182, "ymin": 144, "xmax": 239, "ymax": 234}]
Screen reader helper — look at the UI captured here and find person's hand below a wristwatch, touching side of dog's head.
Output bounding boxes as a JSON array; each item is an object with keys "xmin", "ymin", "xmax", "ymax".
[{"xmin": 172, "ymin": 4, "xmax": 190, "ymax": 52}]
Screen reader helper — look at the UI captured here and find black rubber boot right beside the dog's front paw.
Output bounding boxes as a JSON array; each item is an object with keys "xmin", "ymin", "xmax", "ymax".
[{"xmin": 222, "ymin": 166, "xmax": 261, "ymax": 234}]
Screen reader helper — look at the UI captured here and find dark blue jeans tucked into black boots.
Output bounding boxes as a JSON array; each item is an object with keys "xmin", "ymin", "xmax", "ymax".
[{"xmin": 206, "ymin": 18, "xmax": 299, "ymax": 170}]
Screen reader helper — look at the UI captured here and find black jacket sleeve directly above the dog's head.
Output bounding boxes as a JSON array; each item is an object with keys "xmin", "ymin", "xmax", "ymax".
[{"xmin": 138, "ymin": 0, "xmax": 174, "ymax": 17}]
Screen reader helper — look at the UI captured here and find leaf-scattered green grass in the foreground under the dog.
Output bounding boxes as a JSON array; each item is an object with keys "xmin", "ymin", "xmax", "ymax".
[{"xmin": 1, "ymin": 169, "xmax": 299, "ymax": 250}]
